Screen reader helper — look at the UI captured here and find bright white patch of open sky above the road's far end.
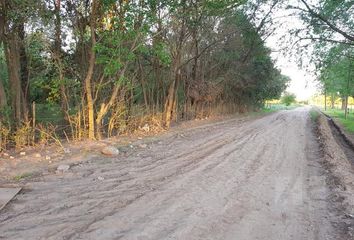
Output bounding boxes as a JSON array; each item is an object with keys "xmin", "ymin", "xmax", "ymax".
[{"xmin": 266, "ymin": 1, "xmax": 318, "ymax": 101}]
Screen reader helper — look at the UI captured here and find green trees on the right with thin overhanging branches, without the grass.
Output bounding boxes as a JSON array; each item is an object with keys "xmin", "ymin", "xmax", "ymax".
[{"xmin": 285, "ymin": 0, "xmax": 354, "ymax": 116}]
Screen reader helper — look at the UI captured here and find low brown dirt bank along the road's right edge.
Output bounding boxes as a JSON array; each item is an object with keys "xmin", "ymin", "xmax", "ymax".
[{"xmin": 317, "ymin": 114, "xmax": 354, "ymax": 237}]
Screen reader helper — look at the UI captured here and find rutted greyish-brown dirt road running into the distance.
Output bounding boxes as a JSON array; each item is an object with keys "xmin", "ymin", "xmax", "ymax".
[{"xmin": 0, "ymin": 108, "xmax": 343, "ymax": 240}]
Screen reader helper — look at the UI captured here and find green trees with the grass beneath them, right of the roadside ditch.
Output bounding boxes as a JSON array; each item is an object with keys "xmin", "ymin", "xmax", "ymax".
[{"xmin": 302, "ymin": 0, "xmax": 354, "ymax": 133}]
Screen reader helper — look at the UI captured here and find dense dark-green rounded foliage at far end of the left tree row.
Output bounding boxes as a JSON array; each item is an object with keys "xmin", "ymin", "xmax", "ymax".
[{"xmin": 215, "ymin": 12, "xmax": 290, "ymax": 106}]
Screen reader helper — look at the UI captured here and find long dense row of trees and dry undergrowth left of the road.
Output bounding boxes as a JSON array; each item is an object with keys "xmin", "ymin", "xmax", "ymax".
[{"xmin": 0, "ymin": 0, "xmax": 289, "ymax": 150}]
